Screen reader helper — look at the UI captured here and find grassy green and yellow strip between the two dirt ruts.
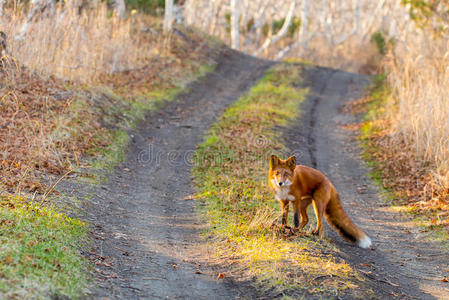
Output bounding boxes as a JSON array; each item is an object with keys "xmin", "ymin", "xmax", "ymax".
[{"xmin": 193, "ymin": 64, "xmax": 366, "ymax": 296}]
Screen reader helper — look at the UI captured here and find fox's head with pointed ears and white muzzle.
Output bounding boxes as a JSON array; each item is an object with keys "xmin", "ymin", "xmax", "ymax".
[{"xmin": 269, "ymin": 155, "xmax": 296, "ymax": 187}]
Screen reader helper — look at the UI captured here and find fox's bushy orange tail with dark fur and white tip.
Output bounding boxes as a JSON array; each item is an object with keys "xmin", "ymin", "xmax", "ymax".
[{"xmin": 326, "ymin": 189, "xmax": 371, "ymax": 248}]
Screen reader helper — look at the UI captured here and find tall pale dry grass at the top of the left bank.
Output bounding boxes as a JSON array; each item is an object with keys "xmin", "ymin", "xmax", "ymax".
[{"xmin": 5, "ymin": 1, "xmax": 159, "ymax": 83}]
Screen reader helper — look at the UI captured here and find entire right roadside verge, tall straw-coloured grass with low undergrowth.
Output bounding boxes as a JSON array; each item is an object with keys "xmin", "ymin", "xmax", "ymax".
[{"xmin": 354, "ymin": 1, "xmax": 449, "ymax": 245}]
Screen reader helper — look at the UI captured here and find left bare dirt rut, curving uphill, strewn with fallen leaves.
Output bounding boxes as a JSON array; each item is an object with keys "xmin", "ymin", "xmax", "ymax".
[{"xmin": 82, "ymin": 50, "xmax": 272, "ymax": 299}]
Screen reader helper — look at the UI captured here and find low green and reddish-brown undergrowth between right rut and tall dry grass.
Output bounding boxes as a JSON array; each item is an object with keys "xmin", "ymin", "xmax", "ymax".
[{"xmin": 358, "ymin": 75, "xmax": 449, "ymax": 232}]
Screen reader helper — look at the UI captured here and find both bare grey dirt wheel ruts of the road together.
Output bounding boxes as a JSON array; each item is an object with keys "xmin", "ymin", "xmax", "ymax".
[{"xmin": 75, "ymin": 50, "xmax": 449, "ymax": 299}]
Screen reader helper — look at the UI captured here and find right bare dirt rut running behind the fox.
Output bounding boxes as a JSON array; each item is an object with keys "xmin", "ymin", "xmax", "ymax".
[{"xmin": 285, "ymin": 67, "xmax": 449, "ymax": 299}]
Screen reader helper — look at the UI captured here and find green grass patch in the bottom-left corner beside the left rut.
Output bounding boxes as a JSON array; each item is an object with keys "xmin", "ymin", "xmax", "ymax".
[{"xmin": 0, "ymin": 196, "xmax": 88, "ymax": 299}]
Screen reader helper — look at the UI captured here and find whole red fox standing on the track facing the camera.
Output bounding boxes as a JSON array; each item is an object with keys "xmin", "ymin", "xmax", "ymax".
[{"xmin": 268, "ymin": 155, "xmax": 371, "ymax": 248}]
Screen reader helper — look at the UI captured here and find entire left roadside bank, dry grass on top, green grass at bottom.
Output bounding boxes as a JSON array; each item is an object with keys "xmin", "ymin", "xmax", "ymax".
[{"xmin": 0, "ymin": 2, "xmax": 219, "ymax": 298}]
